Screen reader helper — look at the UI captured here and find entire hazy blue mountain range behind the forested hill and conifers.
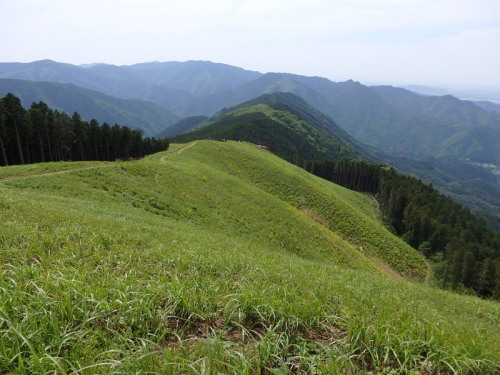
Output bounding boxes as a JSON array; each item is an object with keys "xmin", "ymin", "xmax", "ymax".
[{"xmin": 0, "ymin": 60, "xmax": 500, "ymax": 229}]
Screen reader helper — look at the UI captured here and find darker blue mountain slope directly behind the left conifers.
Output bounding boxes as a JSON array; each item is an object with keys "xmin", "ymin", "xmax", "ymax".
[{"xmin": 0, "ymin": 79, "xmax": 178, "ymax": 136}]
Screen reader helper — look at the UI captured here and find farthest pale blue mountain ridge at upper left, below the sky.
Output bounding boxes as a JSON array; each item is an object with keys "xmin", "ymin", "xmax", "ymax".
[{"xmin": 0, "ymin": 60, "xmax": 261, "ymax": 109}]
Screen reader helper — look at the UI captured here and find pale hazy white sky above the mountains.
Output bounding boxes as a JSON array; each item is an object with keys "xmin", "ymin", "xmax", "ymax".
[{"xmin": 0, "ymin": 0, "xmax": 500, "ymax": 89}]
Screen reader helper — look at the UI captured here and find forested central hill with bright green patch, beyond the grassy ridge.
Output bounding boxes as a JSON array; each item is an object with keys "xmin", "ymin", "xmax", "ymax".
[{"xmin": 174, "ymin": 93, "xmax": 369, "ymax": 160}]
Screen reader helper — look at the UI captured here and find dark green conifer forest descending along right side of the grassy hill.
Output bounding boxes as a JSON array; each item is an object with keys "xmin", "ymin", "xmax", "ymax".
[{"xmin": 294, "ymin": 158, "xmax": 500, "ymax": 299}]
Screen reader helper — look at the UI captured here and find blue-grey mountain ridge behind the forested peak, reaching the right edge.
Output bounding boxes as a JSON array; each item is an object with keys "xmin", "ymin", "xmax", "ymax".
[{"xmin": 172, "ymin": 73, "xmax": 500, "ymax": 164}]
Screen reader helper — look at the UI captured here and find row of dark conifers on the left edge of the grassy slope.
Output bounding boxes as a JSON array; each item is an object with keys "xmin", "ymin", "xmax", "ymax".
[{"xmin": 0, "ymin": 93, "xmax": 169, "ymax": 166}]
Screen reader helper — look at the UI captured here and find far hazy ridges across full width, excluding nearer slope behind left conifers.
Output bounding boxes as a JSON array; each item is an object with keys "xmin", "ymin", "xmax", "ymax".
[{"xmin": 0, "ymin": 60, "xmax": 500, "ymax": 165}]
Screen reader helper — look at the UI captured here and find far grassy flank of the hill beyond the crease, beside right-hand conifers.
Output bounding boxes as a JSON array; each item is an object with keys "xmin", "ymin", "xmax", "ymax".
[{"xmin": 164, "ymin": 142, "xmax": 426, "ymax": 279}]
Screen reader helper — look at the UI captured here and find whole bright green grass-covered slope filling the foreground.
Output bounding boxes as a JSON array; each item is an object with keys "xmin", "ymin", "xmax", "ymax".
[{"xmin": 0, "ymin": 141, "xmax": 499, "ymax": 374}]
